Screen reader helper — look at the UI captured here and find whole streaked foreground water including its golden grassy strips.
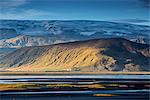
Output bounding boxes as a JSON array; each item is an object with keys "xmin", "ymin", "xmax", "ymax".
[{"xmin": 0, "ymin": 75, "xmax": 150, "ymax": 100}]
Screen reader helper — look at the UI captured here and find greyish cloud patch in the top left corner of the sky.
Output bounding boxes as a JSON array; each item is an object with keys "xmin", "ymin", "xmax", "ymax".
[{"xmin": 0, "ymin": 0, "xmax": 27, "ymax": 9}]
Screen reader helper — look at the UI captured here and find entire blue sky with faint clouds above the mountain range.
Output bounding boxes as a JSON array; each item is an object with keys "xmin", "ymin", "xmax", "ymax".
[{"xmin": 0, "ymin": 0, "xmax": 150, "ymax": 22}]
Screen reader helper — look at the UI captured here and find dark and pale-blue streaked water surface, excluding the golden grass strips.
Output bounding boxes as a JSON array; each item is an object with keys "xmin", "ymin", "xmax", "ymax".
[{"xmin": 0, "ymin": 75, "xmax": 150, "ymax": 100}]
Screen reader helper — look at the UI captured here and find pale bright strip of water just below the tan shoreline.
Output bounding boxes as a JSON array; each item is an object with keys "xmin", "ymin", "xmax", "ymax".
[{"xmin": 0, "ymin": 75, "xmax": 150, "ymax": 79}]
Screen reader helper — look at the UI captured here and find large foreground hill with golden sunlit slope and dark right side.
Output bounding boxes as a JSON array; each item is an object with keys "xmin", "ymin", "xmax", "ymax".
[{"xmin": 0, "ymin": 38, "xmax": 150, "ymax": 71}]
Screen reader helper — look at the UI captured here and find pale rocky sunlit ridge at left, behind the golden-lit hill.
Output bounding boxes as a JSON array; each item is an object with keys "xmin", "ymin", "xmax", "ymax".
[{"xmin": 0, "ymin": 35, "xmax": 77, "ymax": 48}]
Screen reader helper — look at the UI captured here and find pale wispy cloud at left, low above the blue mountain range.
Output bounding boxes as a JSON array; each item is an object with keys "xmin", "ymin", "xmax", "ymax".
[{"xmin": 0, "ymin": 9, "xmax": 54, "ymax": 20}]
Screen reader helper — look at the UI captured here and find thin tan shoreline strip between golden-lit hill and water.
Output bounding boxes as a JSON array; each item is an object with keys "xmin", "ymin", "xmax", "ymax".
[{"xmin": 0, "ymin": 72, "xmax": 150, "ymax": 75}]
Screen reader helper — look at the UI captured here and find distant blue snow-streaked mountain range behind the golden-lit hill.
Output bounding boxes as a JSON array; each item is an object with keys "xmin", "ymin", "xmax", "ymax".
[{"xmin": 0, "ymin": 20, "xmax": 150, "ymax": 48}]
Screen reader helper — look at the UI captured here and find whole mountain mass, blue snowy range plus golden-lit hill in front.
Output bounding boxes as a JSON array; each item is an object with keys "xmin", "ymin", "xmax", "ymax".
[{"xmin": 0, "ymin": 20, "xmax": 150, "ymax": 71}]
